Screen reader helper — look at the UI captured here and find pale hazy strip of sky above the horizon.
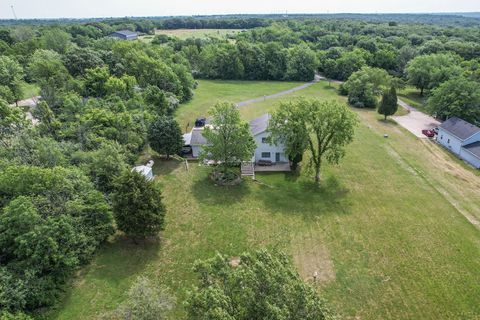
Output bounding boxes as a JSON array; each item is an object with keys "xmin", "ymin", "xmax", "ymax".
[{"xmin": 0, "ymin": 0, "xmax": 480, "ymax": 19}]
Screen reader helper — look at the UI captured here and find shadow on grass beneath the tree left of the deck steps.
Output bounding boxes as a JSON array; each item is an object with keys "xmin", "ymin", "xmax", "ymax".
[{"xmin": 192, "ymin": 175, "xmax": 250, "ymax": 206}]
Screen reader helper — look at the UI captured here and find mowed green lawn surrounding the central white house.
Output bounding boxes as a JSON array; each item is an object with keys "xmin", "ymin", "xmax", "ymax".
[{"xmin": 49, "ymin": 81, "xmax": 480, "ymax": 319}]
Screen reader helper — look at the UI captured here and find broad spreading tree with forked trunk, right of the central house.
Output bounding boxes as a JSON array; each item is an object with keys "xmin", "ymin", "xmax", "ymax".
[{"xmin": 270, "ymin": 99, "xmax": 357, "ymax": 183}]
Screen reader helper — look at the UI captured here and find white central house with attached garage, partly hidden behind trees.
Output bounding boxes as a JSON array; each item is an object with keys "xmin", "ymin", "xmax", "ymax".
[{"xmin": 183, "ymin": 114, "xmax": 288, "ymax": 163}]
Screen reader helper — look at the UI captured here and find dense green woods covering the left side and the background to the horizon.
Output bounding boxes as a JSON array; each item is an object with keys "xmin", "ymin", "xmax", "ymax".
[{"xmin": 0, "ymin": 12, "xmax": 480, "ymax": 317}]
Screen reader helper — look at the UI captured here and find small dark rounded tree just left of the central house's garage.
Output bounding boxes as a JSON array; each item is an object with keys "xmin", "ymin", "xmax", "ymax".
[{"xmin": 148, "ymin": 116, "xmax": 184, "ymax": 159}]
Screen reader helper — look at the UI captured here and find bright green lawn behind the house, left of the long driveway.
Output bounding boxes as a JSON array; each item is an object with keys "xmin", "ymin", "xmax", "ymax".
[{"xmin": 175, "ymin": 80, "xmax": 302, "ymax": 131}]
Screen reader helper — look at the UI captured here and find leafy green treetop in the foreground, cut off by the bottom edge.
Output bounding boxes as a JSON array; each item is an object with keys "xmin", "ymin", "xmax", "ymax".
[{"xmin": 187, "ymin": 250, "xmax": 334, "ymax": 320}]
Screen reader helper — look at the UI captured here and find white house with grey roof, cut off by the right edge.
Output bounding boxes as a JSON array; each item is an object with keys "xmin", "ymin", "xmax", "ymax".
[{"xmin": 437, "ymin": 117, "xmax": 480, "ymax": 168}]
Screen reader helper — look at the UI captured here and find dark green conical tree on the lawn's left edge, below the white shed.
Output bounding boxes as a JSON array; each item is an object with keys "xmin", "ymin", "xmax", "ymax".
[{"xmin": 112, "ymin": 170, "xmax": 165, "ymax": 239}]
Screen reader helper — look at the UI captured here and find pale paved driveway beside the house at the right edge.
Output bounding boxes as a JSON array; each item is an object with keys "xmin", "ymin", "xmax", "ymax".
[{"xmin": 392, "ymin": 99, "xmax": 440, "ymax": 138}]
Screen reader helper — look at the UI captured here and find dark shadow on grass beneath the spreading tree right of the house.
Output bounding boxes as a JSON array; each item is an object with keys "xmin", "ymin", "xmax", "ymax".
[{"xmin": 257, "ymin": 174, "xmax": 351, "ymax": 219}]
